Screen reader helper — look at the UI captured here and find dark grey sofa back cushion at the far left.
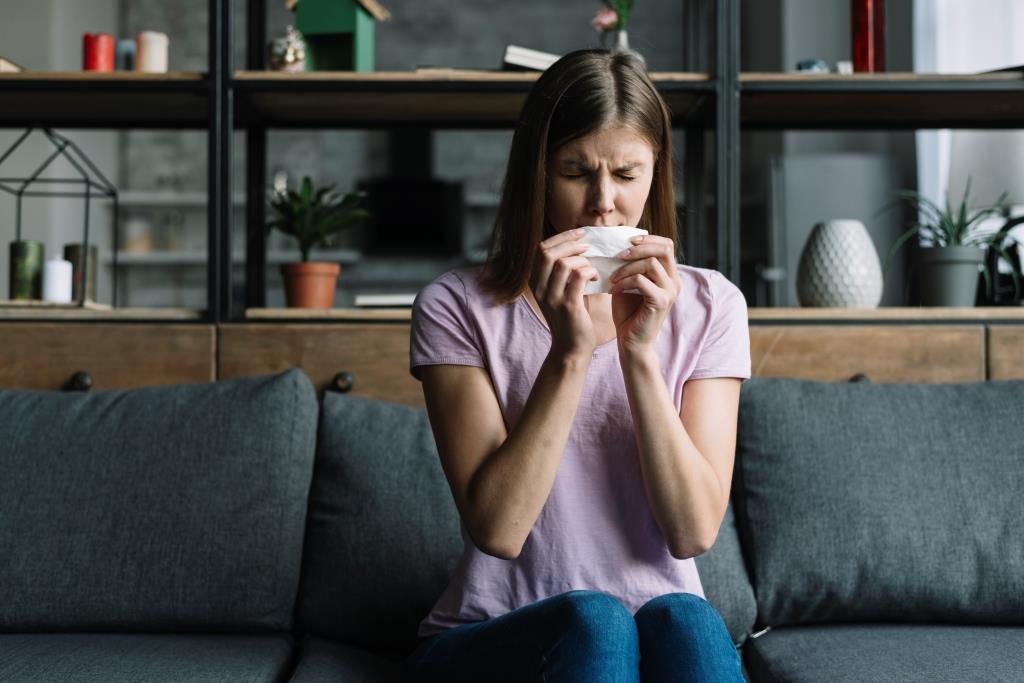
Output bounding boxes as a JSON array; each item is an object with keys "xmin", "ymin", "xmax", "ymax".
[{"xmin": 0, "ymin": 370, "xmax": 317, "ymax": 632}]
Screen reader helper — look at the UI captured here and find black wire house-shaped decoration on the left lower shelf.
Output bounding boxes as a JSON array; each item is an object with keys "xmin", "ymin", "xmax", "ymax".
[{"xmin": 0, "ymin": 128, "xmax": 120, "ymax": 307}]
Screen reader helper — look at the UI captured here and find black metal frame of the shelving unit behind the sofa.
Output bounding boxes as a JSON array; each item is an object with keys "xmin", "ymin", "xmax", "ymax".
[{"xmin": 16, "ymin": 0, "xmax": 1024, "ymax": 324}]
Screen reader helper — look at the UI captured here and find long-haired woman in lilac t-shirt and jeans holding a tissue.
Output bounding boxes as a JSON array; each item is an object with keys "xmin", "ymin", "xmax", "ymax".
[{"xmin": 410, "ymin": 50, "xmax": 751, "ymax": 681}]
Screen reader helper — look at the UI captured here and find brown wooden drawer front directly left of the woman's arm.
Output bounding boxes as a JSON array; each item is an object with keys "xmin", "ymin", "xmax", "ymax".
[{"xmin": 219, "ymin": 323, "xmax": 424, "ymax": 408}]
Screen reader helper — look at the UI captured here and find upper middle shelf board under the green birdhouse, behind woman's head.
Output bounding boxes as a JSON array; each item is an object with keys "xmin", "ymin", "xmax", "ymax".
[{"xmin": 232, "ymin": 69, "xmax": 714, "ymax": 128}]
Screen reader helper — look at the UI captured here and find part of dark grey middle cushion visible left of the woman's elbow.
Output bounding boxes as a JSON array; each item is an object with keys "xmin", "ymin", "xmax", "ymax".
[{"xmin": 296, "ymin": 392, "xmax": 462, "ymax": 652}]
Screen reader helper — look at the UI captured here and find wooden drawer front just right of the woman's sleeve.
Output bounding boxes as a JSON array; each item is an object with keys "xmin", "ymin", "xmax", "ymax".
[{"xmin": 750, "ymin": 325, "xmax": 985, "ymax": 383}]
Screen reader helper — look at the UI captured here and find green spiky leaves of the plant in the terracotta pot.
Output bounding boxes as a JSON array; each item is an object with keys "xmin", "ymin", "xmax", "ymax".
[{"xmin": 266, "ymin": 175, "xmax": 370, "ymax": 261}]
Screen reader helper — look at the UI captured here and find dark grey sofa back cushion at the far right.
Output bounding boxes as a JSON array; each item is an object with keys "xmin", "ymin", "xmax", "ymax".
[{"xmin": 733, "ymin": 378, "xmax": 1024, "ymax": 626}]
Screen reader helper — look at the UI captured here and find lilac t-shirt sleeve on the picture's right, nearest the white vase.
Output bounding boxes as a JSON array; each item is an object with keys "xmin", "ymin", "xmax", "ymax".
[{"xmin": 689, "ymin": 270, "xmax": 751, "ymax": 380}]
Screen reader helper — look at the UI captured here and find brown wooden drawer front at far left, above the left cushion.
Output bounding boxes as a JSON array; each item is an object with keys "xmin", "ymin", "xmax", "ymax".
[{"xmin": 0, "ymin": 323, "xmax": 216, "ymax": 389}]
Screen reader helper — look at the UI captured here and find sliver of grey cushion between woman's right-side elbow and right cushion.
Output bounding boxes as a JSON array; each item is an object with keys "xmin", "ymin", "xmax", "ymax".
[{"xmin": 694, "ymin": 503, "xmax": 758, "ymax": 645}]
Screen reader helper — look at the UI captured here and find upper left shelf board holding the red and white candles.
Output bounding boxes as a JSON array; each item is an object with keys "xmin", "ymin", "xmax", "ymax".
[{"xmin": 0, "ymin": 72, "xmax": 209, "ymax": 128}]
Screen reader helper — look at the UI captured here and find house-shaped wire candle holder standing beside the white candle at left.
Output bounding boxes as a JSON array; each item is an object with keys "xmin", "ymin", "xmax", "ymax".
[{"xmin": 0, "ymin": 128, "xmax": 120, "ymax": 307}]
